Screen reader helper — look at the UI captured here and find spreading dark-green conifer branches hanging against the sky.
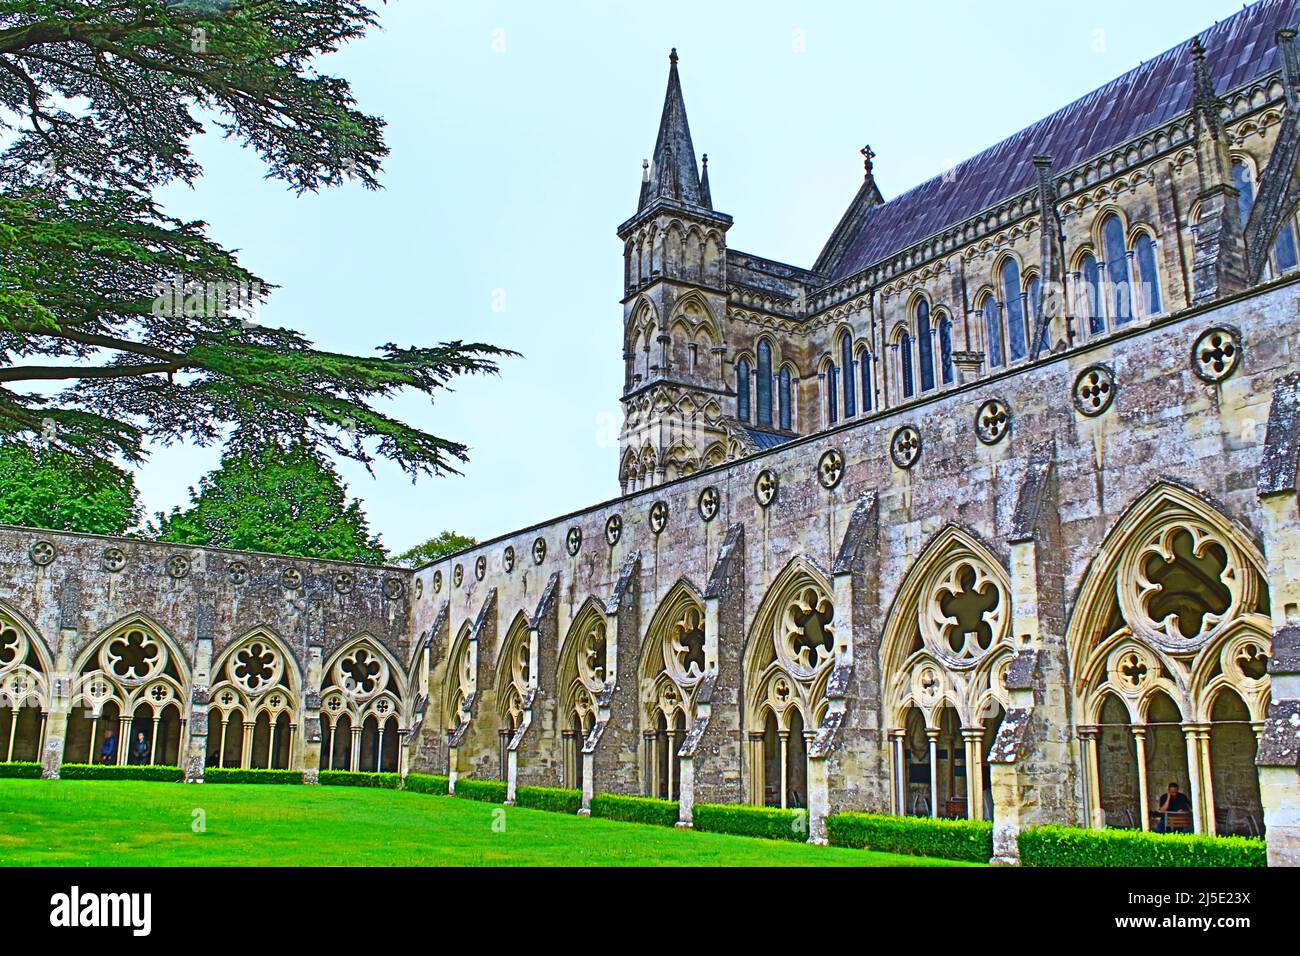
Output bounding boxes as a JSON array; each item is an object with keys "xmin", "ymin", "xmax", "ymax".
[{"xmin": 0, "ymin": 0, "xmax": 511, "ymax": 476}]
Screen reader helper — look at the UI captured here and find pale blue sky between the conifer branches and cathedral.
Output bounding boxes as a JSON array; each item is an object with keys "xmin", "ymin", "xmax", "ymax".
[{"xmin": 137, "ymin": 0, "xmax": 1239, "ymax": 551}]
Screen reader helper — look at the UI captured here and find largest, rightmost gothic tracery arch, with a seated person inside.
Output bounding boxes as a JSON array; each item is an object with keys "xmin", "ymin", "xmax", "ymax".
[{"xmin": 1066, "ymin": 481, "xmax": 1271, "ymax": 834}]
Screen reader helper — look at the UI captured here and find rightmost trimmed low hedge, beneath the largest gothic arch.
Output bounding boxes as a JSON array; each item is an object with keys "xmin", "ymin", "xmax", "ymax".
[{"xmin": 1018, "ymin": 826, "xmax": 1269, "ymax": 866}]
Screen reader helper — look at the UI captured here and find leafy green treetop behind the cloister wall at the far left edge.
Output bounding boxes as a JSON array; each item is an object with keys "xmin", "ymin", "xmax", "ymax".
[{"xmin": 0, "ymin": 442, "xmax": 140, "ymax": 535}]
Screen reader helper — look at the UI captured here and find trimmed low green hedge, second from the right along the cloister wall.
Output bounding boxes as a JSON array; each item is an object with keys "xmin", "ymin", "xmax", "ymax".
[{"xmin": 826, "ymin": 813, "xmax": 993, "ymax": 864}]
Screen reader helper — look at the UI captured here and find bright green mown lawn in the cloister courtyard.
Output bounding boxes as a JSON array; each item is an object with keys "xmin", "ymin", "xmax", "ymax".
[{"xmin": 0, "ymin": 779, "xmax": 977, "ymax": 866}]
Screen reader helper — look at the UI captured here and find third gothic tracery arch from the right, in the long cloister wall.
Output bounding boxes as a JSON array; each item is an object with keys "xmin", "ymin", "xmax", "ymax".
[{"xmin": 742, "ymin": 555, "xmax": 849, "ymax": 806}]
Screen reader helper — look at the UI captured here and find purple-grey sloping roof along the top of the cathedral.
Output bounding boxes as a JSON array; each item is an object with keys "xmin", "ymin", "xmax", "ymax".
[{"xmin": 831, "ymin": 0, "xmax": 1300, "ymax": 281}]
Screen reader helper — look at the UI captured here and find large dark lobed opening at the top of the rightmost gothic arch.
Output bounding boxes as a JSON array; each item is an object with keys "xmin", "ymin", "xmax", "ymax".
[{"xmin": 1141, "ymin": 528, "xmax": 1232, "ymax": 640}]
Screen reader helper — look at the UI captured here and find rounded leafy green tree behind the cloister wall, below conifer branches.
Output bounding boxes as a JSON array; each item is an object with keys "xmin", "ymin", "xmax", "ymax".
[{"xmin": 155, "ymin": 445, "xmax": 386, "ymax": 564}]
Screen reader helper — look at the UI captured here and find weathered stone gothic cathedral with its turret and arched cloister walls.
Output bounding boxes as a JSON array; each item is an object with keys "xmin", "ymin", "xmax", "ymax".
[{"xmin": 0, "ymin": 0, "xmax": 1300, "ymax": 865}]
